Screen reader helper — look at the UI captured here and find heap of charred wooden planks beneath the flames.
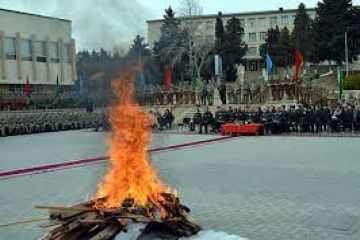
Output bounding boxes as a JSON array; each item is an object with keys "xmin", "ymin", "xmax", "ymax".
[{"xmin": 36, "ymin": 194, "xmax": 201, "ymax": 240}]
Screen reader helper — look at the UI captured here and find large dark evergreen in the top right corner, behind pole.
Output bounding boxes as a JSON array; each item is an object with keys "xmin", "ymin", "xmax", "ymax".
[{"xmin": 314, "ymin": 0, "xmax": 360, "ymax": 64}]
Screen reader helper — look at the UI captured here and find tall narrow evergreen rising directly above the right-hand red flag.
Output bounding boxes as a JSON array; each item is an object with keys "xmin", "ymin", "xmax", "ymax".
[{"xmin": 291, "ymin": 3, "xmax": 313, "ymax": 60}]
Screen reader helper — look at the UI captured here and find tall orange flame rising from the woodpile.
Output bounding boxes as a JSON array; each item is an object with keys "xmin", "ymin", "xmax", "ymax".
[{"xmin": 96, "ymin": 72, "xmax": 169, "ymax": 209}]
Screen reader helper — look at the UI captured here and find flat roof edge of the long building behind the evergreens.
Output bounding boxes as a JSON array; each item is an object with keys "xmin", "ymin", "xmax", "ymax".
[{"xmin": 146, "ymin": 8, "xmax": 315, "ymax": 23}]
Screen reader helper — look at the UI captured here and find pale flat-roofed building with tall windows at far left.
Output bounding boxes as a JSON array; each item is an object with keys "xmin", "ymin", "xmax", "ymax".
[{"xmin": 0, "ymin": 9, "xmax": 77, "ymax": 94}]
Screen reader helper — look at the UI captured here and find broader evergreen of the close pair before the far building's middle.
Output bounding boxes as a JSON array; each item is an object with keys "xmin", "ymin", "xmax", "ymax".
[{"xmin": 221, "ymin": 17, "xmax": 247, "ymax": 81}]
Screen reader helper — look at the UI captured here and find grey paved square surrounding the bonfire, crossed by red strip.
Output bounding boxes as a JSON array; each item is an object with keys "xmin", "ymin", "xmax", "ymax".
[{"xmin": 0, "ymin": 131, "xmax": 360, "ymax": 240}]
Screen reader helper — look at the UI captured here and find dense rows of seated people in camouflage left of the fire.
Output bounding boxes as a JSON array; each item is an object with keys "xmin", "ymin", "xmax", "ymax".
[{"xmin": 0, "ymin": 110, "xmax": 104, "ymax": 137}]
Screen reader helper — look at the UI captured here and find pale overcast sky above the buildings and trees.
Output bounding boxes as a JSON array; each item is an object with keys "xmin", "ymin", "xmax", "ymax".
[{"xmin": 0, "ymin": 0, "xmax": 360, "ymax": 50}]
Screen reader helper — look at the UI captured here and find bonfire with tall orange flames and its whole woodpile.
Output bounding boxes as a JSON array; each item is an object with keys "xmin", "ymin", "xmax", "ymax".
[{"xmin": 38, "ymin": 72, "xmax": 200, "ymax": 240}]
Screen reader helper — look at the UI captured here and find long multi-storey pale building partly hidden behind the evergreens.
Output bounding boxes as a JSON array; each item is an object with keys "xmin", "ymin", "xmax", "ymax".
[{"xmin": 147, "ymin": 8, "xmax": 315, "ymax": 72}]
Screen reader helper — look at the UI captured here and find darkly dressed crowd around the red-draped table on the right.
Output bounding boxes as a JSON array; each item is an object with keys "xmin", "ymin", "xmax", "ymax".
[{"xmin": 190, "ymin": 105, "xmax": 360, "ymax": 135}]
